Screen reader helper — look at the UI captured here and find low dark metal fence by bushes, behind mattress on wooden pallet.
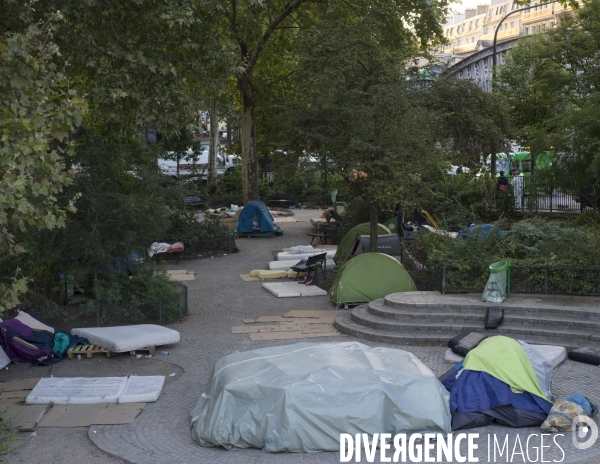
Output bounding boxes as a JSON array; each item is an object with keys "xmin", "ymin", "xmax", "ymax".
[{"xmin": 8, "ymin": 284, "xmax": 188, "ymax": 331}]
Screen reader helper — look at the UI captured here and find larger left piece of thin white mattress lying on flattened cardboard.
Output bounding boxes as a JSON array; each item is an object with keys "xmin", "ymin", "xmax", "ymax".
[{"xmin": 27, "ymin": 377, "xmax": 127, "ymax": 404}]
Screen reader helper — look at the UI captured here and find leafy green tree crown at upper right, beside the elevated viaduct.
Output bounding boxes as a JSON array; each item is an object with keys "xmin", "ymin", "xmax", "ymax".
[{"xmin": 499, "ymin": 0, "xmax": 600, "ymax": 193}]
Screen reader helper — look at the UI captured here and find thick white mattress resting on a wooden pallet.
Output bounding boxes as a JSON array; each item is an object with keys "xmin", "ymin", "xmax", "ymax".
[{"xmin": 71, "ymin": 324, "xmax": 180, "ymax": 353}]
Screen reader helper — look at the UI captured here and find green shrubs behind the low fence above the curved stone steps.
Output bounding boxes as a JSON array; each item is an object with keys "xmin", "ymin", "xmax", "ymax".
[{"xmin": 406, "ymin": 219, "xmax": 600, "ymax": 294}]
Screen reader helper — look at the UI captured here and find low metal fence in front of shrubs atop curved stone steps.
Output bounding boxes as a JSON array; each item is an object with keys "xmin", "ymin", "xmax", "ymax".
[{"xmin": 404, "ymin": 260, "xmax": 600, "ymax": 296}]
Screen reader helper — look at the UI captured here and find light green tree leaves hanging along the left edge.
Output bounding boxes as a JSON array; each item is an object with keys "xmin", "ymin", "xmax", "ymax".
[{"xmin": 0, "ymin": 26, "xmax": 85, "ymax": 313}]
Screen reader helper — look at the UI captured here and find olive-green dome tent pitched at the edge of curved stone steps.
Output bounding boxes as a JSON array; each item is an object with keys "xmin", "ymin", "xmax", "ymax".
[{"xmin": 329, "ymin": 253, "xmax": 417, "ymax": 304}]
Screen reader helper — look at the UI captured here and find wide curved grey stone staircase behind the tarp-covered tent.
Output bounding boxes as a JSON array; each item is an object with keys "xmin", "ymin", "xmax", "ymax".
[{"xmin": 334, "ymin": 292, "xmax": 600, "ymax": 348}]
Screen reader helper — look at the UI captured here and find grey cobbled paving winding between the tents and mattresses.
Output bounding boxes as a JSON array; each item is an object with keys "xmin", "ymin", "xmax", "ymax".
[{"xmin": 14, "ymin": 210, "xmax": 600, "ymax": 464}]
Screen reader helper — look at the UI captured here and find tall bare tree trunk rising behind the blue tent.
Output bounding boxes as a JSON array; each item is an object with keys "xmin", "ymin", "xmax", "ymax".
[{"xmin": 240, "ymin": 86, "xmax": 260, "ymax": 204}]
